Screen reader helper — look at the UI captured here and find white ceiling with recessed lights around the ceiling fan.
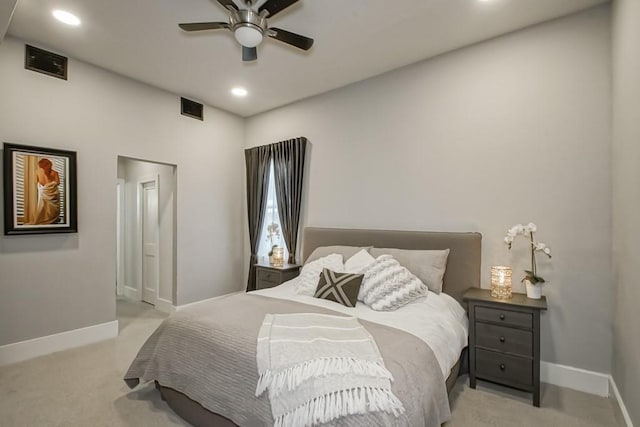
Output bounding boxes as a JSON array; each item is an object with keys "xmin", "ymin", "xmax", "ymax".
[{"xmin": 9, "ymin": 0, "xmax": 608, "ymax": 117}]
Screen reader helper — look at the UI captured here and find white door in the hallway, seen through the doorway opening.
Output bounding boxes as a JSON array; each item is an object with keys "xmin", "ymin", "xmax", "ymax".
[{"xmin": 141, "ymin": 181, "xmax": 159, "ymax": 305}]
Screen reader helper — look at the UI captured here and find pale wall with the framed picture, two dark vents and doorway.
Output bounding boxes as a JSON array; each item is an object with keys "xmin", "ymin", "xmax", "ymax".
[{"xmin": 0, "ymin": 38, "xmax": 245, "ymax": 345}]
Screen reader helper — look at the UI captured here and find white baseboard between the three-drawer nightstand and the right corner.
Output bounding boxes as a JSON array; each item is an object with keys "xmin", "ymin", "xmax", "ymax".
[{"xmin": 540, "ymin": 362, "xmax": 609, "ymax": 397}]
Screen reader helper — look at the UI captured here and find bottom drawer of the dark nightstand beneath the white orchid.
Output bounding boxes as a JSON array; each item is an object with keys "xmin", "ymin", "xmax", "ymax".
[{"xmin": 476, "ymin": 348, "xmax": 533, "ymax": 388}]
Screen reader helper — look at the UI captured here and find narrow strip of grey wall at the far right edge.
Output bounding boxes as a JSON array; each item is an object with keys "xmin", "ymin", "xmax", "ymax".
[{"xmin": 612, "ymin": 0, "xmax": 640, "ymax": 425}]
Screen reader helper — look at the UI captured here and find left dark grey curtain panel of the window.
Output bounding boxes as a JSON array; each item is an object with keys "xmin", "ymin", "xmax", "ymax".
[{"xmin": 244, "ymin": 145, "xmax": 271, "ymax": 291}]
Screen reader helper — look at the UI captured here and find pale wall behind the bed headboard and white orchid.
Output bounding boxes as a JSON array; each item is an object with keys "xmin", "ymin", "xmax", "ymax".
[{"xmin": 245, "ymin": 7, "xmax": 612, "ymax": 372}]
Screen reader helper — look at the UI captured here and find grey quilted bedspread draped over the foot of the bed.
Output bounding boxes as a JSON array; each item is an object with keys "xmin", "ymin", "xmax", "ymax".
[{"xmin": 124, "ymin": 293, "xmax": 450, "ymax": 427}]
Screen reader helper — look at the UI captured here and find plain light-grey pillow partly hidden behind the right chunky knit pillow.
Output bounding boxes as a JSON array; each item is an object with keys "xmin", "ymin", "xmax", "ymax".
[{"xmin": 370, "ymin": 248, "xmax": 449, "ymax": 294}]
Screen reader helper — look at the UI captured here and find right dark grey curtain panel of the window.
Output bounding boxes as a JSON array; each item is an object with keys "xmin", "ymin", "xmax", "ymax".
[{"xmin": 271, "ymin": 138, "xmax": 307, "ymax": 264}]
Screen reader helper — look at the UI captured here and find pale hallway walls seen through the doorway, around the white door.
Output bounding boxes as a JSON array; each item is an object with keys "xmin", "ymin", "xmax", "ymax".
[{"xmin": 118, "ymin": 157, "xmax": 176, "ymax": 304}]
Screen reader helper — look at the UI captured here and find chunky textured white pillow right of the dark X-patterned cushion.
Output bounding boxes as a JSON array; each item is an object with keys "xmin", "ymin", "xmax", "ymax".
[{"xmin": 358, "ymin": 255, "xmax": 428, "ymax": 311}]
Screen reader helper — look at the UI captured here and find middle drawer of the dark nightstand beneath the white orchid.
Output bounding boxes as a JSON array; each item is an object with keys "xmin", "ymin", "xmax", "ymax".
[{"xmin": 475, "ymin": 322, "xmax": 533, "ymax": 357}]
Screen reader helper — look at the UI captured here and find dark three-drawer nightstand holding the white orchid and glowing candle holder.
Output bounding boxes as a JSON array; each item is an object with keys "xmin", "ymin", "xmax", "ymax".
[{"xmin": 463, "ymin": 288, "xmax": 547, "ymax": 407}]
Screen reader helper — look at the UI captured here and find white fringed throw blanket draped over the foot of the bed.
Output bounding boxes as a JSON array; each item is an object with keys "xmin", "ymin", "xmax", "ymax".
[{"xmin": 256, "ymin": 313, "xmax": 404, "ymax": 427}]
